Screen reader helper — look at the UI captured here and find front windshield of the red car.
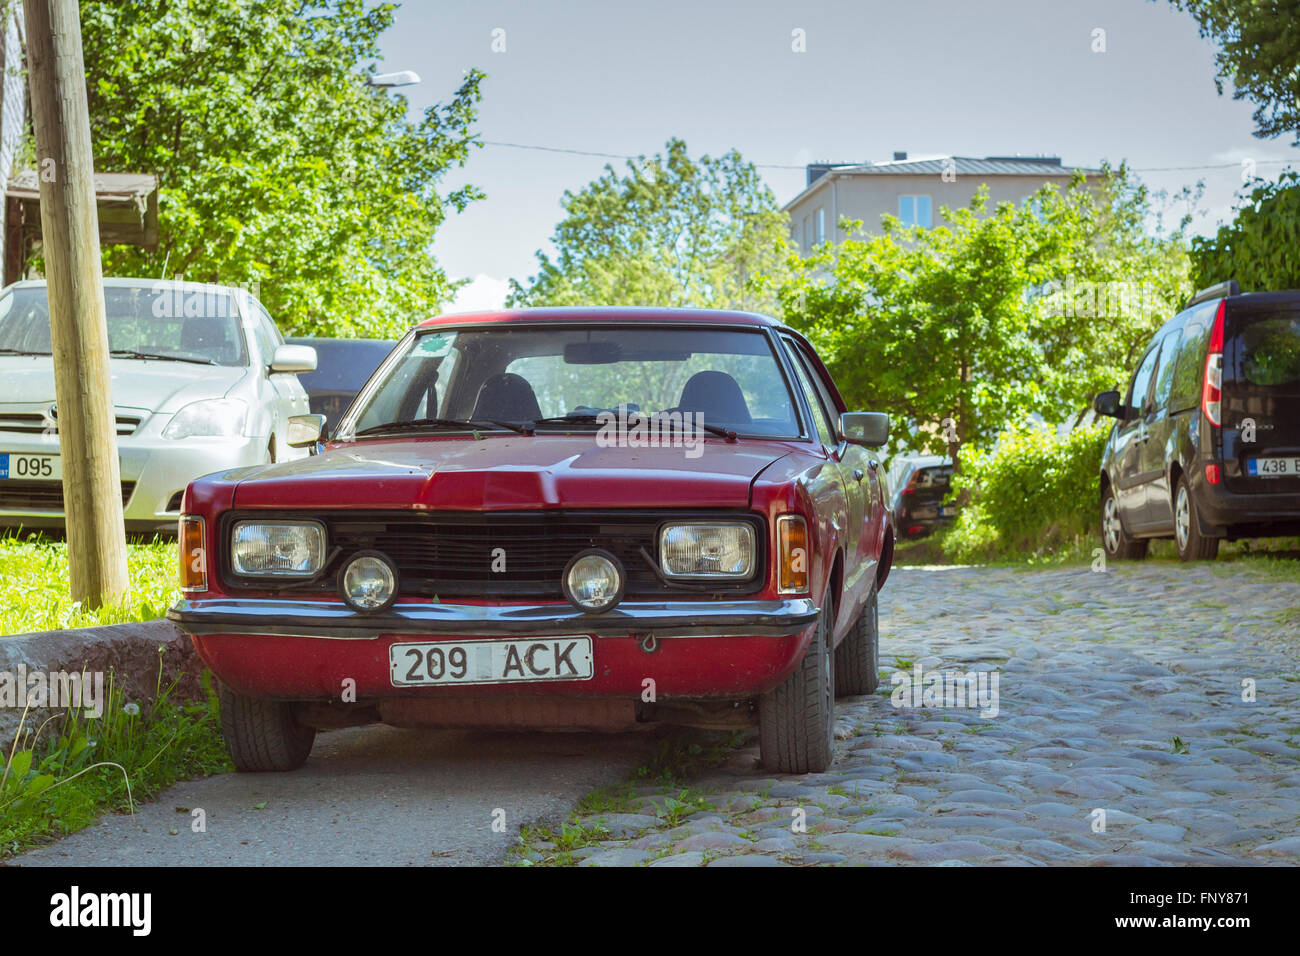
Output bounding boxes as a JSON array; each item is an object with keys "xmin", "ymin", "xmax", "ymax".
[{"xmin": 351, "ymin": 325, "xmax": 800, "ymax": 438}]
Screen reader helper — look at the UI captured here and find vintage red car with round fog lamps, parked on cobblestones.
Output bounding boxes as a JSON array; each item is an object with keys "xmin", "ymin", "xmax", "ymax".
[{"xmin": 168, "ymin": 308, "xmax": 894, "ymax": 773}]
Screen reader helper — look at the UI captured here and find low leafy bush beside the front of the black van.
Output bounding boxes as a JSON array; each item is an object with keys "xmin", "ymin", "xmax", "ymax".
[{"xmin": 943, "ymin": 421, "xmax": 1110, "ymax": 561}]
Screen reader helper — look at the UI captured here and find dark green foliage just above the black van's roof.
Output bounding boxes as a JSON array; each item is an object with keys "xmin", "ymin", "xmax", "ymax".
[{"xmin": 1192, "ymin": 172, "xmax": 1300, "ymax": 291}]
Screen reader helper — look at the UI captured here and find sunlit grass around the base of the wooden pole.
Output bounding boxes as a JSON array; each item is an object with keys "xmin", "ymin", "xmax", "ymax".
[{"xmin": 0, "ymin": 532, "xmax": 177, "ymax": 637}]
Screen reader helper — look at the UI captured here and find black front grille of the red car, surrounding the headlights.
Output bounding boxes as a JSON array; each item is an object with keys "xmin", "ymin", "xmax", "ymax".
[{"xmin": 228, "ymin": 511, "xmax": 767, "ymax": 600}]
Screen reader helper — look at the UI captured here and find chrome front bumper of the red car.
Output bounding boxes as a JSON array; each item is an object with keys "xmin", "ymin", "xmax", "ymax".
[{"xmin": 166, "ymin": 597, "xmax": 820, "ymax": 639}]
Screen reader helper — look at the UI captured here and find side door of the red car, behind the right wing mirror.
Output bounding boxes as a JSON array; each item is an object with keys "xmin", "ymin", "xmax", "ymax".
[{"xmin": 783, "ymin": 336, "xmax": 879, "ymax": 624}]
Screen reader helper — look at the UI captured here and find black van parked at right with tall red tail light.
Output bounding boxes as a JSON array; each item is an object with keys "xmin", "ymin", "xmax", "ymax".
[{"xmin": 1093, "ymin": 282, "xmax": 1300, "ymax": 561}]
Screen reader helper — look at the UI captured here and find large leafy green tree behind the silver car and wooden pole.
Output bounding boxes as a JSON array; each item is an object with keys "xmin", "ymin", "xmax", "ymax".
[{"xmin": 73, "ymin": 0, "xmax": 482, "ymax": 336}]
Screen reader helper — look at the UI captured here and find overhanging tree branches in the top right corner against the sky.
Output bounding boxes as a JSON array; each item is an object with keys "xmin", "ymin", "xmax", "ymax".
[{"xmin": 1170, "ymin": 0, "xmax": 1300, "ymax": 146}]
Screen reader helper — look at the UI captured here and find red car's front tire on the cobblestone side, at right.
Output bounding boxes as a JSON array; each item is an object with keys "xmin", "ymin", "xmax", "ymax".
[{"xmin": 758, "ymin": 594, "xmax": 835, "ymax": 774}]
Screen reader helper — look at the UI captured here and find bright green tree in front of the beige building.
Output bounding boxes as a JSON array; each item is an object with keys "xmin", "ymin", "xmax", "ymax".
[{"xmin": 780, "ymin": 168, "xmax": 1187, "ymax": 463}]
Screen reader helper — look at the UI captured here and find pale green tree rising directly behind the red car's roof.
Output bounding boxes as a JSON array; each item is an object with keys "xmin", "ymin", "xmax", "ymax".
[{"xmin": 508, "ymin": 139, "xmax": 789, "ymax": 311}]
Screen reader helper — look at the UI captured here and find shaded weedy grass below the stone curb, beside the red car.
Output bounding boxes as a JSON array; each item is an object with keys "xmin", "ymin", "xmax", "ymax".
[{"xmin": 0, "ymin": 669, "xmax": 233, "ymax": 860}]
